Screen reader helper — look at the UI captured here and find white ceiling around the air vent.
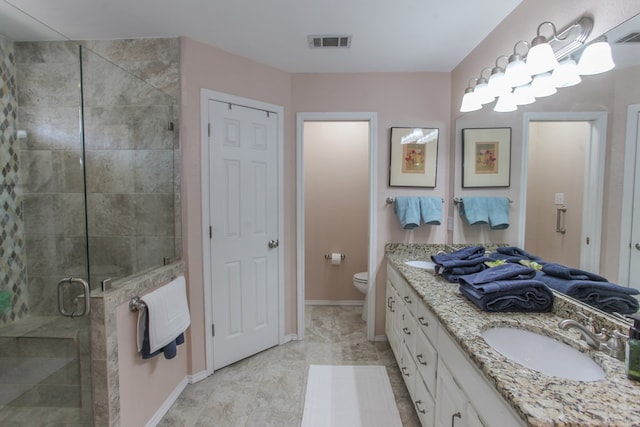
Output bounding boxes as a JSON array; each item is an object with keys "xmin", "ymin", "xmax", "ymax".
[{"xmin": 0, "ymin": 0, "xmax": 522, "ymax": 72}]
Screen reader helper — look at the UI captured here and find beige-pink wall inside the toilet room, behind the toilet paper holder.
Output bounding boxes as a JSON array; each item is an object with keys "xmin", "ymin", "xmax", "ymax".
[{"xmin": 303, "ymin": 122, "xmax": 369, "ymax": 301}]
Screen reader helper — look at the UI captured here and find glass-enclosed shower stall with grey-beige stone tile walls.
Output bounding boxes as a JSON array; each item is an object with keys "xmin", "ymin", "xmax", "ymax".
[{"xmin": 0, "ymin": 10, "xmax": 181, "ymax": 425}]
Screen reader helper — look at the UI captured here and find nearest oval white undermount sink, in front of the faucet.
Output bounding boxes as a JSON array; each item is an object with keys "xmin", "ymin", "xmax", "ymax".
[{"xmin": 482, "ymin": 327, "xmax": 605, "ymax": 381}]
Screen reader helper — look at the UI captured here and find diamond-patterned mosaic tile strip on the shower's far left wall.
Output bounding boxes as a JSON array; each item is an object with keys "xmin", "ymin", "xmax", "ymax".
[{"xmin": 0, "ymin": 37, "xmax": 28, "ymax": 324}]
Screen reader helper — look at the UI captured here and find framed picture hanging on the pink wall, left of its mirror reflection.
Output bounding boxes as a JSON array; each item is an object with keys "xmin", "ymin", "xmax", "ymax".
[{"xmin": 389, "ymin": 127, "xmax": 439, "ymax": 188}]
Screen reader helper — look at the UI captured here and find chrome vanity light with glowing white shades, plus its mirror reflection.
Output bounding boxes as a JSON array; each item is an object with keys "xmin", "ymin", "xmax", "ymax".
[{"xmin": 460, "ymin": 16, "xmax": 615, "ymax": 113}]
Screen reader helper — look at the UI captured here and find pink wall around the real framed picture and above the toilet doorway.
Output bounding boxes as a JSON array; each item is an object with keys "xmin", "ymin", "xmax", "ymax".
[{"xmin": 292, "ymin": 73, "xmax": 451, "ymax": 335}]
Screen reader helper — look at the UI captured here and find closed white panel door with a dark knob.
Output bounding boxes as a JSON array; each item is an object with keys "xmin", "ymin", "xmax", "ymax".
[{"xmin": 209, "ymin": 100, "xmax": 279, "ymax": 369}]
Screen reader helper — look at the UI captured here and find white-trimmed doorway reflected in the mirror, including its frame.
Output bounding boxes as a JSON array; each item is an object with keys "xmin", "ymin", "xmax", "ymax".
[{"xmin": 520, "ymin": 113, "xmax": 606, "ymax": 272}]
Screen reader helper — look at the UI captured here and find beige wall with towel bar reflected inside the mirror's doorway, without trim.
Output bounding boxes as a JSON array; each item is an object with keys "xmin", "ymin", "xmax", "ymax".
[{"xmin": 525, "ymin": 121, "xmax": 591, "ymax": 268}]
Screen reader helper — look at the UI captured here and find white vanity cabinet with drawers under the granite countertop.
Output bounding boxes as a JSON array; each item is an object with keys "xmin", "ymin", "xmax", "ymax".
[{"xmin": 385, "ymin": 263, "xmax": 525, "ymax": 427}]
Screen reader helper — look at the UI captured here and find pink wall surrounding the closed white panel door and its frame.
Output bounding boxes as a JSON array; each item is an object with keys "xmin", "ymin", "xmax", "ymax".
[{"xmin": 180, "ymin": 38, "xmax": 296, "ymax": 373}]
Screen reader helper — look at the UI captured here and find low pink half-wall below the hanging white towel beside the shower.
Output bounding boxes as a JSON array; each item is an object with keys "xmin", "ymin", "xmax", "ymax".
[{"xmin": 116, "ymin": 302, "xmax": 189, "ymax": 426}]
